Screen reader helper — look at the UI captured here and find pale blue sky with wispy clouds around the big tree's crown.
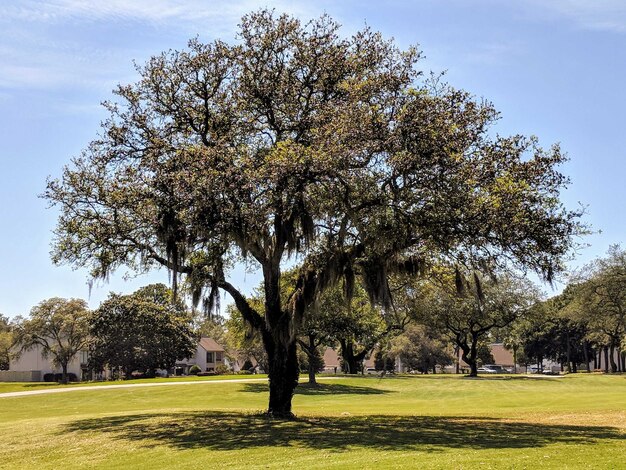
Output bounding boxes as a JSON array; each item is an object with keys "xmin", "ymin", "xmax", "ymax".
[{"xmin": 0, "ymin": 0, "xmax": 626, "ymax": 316}]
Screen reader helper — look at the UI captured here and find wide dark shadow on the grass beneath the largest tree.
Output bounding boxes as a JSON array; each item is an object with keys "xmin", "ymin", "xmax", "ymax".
[{"xmin": 61, "ymin": 411, "xmax": 626, "ymax": 452}]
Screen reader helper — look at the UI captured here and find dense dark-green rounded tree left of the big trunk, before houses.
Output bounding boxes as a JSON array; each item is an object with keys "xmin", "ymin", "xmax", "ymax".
[{"xmin": 89, "ymin": 284, "xmax": 196, "ymax": 379}]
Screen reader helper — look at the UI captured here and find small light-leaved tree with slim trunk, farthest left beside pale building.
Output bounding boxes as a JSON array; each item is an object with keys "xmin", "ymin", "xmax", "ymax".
[{"xmin": 13, "ymin": 297, "xmax": 91, "ymax": 384}]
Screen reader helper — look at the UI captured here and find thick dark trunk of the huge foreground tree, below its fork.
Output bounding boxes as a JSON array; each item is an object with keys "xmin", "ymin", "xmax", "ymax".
[{"xmin": 263, "ymin": 333, "xmax": 299, "ymax": 419}]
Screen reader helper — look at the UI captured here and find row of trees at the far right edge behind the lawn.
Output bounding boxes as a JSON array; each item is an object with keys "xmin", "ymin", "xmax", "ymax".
[{"xmin": 509, "ymin": 245, "xmax": 626, "ymax": 372}]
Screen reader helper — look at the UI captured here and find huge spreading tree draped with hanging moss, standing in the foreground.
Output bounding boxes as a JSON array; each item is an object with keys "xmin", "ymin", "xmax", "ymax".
[{"xmin": 45, "ymin": 10, "xmax": 580, "ymax": 417}]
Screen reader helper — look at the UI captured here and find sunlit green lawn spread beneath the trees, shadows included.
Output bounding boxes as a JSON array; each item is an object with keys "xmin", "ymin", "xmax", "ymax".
[{"xmin": 0, "ymin": 375, "xmax": 626, "ymax": 469}]
